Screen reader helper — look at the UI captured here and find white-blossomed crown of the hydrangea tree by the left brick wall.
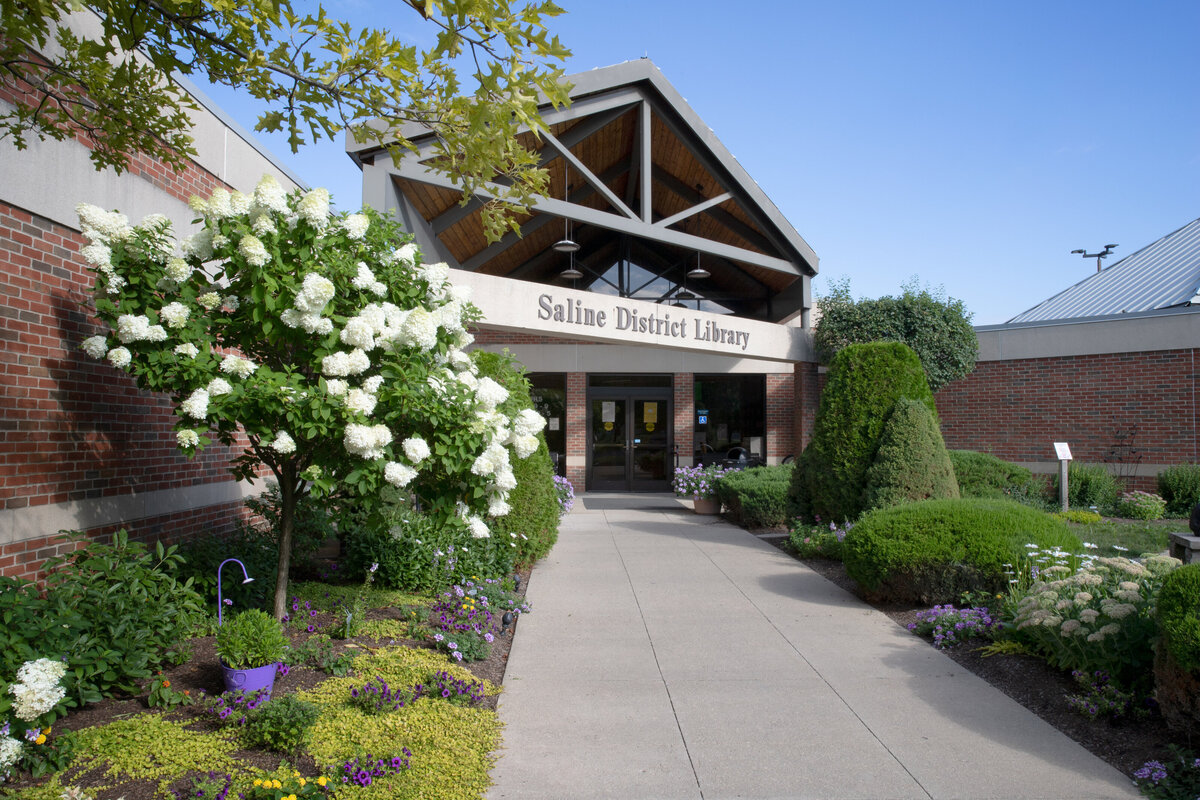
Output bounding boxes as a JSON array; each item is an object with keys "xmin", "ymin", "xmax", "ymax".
[{"xmin": 78, "ymin": 176, "xmax": 545, "ymax": 614}]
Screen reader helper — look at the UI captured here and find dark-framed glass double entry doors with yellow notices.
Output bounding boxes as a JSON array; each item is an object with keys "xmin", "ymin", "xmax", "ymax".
[{"xmin": 588, "ymin": 390, "xmax": 674, "ymax": 492}]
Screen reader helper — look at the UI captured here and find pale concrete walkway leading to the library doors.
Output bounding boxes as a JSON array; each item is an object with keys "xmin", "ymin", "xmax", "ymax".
[{"xmin": 488, "ymin": 494, "xmax": 1138, "ymax": 800}]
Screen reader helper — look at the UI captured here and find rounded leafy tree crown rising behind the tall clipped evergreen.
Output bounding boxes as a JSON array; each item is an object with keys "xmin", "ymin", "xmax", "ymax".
[{"xmin": 812, "ymin": 277, "xmax": 979, "ymax": 392}]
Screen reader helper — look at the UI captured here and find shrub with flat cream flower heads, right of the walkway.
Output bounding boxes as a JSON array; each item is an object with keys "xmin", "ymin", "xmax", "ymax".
[{"xmin": 1013, "ymin": 557, "xmax": 1178, "ymax": 690}]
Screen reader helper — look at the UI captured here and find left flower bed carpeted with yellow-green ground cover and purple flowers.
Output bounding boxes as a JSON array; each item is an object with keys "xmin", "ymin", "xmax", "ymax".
[{"xmin": 0, "ymin": 537, "xmax": 529, "ymax": 800}]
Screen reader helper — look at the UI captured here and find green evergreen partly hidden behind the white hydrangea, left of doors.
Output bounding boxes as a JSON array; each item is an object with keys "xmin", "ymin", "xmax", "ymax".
[{"xmin": 472, "ymin": 350, "xmax": 559, "ymax": 564}]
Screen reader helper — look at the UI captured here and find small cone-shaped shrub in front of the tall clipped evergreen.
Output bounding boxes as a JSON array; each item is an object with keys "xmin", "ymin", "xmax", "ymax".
[{"xmin": 863, "ymin": 397, "xmax": 959, "ymax": 509}]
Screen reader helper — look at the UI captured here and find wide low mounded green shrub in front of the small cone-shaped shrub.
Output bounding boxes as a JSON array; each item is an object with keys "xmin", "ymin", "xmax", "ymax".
[{"xmin": 842, "ymin": 498, "xmax": 1081, "ymax": 604}]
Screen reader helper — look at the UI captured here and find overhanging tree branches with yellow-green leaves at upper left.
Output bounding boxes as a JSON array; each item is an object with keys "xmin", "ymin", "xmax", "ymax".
[{"xmin": 0, "ymin": 0, "xmax": 570, "ymax": 239}]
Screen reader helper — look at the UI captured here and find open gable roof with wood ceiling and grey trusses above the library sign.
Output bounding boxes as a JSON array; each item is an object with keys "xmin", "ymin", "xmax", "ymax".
[{"xmin": 347, "ymin": 59, "xmax": 817, "ymax": 321}]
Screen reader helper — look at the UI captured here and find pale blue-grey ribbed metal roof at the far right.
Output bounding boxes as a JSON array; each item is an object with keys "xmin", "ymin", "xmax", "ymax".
[{"xmin": 1008, "ymin": 219, "xmax": 1200, "ymax": 323}]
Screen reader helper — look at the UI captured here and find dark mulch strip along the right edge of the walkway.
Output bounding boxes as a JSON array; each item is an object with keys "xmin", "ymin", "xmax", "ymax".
[{"xmin": 782, "ymin": 551, "xmax": 1185, "ymax": 778}]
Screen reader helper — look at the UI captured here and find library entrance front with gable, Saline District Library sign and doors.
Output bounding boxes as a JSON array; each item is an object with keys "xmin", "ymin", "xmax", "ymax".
[{"xmin": 348, "ymin": 59, "xmax": 817, "ymax": 491}]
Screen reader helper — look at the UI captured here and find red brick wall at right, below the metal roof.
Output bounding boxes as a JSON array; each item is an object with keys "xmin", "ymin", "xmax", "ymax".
[{"xmin": 937, "ymin": 349, "xmax": 1200, "ymax": 488}]
